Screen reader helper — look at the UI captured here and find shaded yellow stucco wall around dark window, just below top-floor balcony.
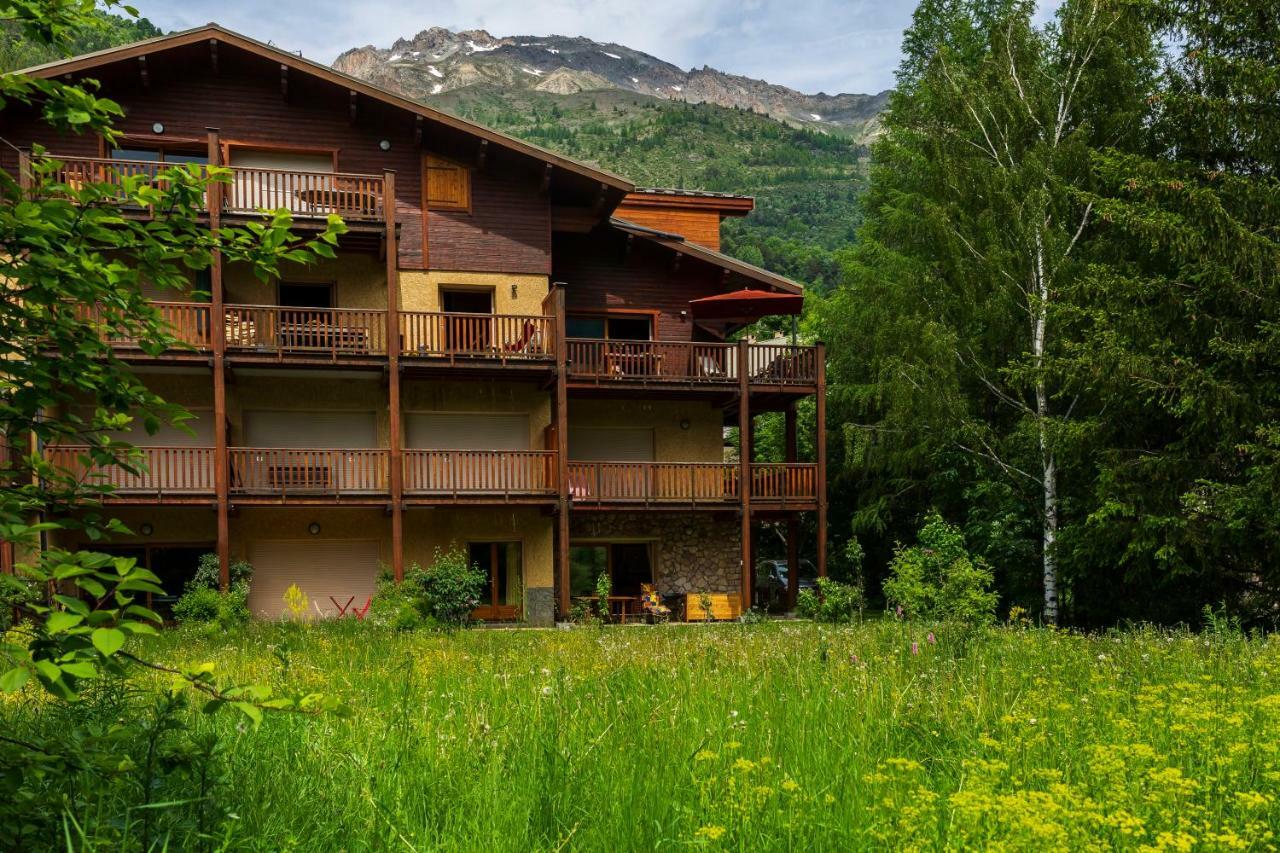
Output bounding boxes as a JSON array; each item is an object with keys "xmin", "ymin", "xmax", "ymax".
[{"xmin": 223, "ymin": 251, "xmax": 387, "ymax": 309}]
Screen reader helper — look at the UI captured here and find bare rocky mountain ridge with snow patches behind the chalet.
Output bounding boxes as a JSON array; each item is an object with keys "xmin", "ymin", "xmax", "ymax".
[{"xmin": 333, "ymin": 27, "xmax": 887, "ymax": 141}]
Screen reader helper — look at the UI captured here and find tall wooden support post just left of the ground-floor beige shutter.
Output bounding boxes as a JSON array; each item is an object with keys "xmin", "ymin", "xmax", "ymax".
[{"xmin": 206, "ymin": 127, "xmax": 232, "ymax": 589}]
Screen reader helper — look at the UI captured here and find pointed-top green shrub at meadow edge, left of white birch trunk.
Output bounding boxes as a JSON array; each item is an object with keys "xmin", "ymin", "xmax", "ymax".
[{"xmin": 884, "ymin": 512, "xmax": 997, "ymax": 624}]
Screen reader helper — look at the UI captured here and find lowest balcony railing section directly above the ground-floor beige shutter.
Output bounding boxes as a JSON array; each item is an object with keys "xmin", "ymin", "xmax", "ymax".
[{"xmin": 227, "ymin": 447, "xmax": 388, "ymax": 497}]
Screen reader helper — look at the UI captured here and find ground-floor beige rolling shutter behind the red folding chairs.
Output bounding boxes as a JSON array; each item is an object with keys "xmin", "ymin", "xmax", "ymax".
[{"xmin": 248, "ymin": 539, "xmax": 379, "ymax": 619}]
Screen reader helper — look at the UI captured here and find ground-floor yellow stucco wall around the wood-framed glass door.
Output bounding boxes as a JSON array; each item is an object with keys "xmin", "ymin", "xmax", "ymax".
[{"xmin": 404, "ymin": 507, "xmax": 554, "ymax": 590}]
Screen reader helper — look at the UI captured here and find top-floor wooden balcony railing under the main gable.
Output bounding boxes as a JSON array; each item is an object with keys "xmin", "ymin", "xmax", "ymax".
[{"xmin": 40, "ymin": 156, "xmax": 385, "ymax": 222}]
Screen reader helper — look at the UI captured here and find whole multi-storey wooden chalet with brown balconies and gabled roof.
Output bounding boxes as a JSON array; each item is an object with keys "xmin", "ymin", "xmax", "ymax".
[{"xmin": 0, "ymin": 24, "xmax": 827, "ymax": 624}]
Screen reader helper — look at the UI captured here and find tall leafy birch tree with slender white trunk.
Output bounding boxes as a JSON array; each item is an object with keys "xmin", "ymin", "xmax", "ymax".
[{"xmin": 819, "ymin": 0, "xmax": 1156, "ymax": 622}]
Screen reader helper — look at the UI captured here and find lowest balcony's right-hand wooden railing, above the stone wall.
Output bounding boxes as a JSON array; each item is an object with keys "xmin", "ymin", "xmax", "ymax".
[{"xmin": 568, "ymin": 462, "xmax": 817, "ymax": 508}]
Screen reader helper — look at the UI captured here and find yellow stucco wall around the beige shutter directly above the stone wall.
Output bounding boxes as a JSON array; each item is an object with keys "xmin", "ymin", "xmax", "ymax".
[{"xmin": 568, "ymin": 398, "xmax": 724, "ymax": 462}]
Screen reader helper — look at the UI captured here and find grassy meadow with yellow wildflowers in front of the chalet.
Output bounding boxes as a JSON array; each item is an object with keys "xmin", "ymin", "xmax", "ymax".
[{"xmin": 0, "ymin": 620, "xmax": 1280, "ymax": 850}]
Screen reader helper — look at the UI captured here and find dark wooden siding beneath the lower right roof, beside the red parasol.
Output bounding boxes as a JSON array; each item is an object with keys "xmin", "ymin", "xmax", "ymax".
[{"xmin": 552, "ymin": 231, "xmax": 741, "ymax": 341}]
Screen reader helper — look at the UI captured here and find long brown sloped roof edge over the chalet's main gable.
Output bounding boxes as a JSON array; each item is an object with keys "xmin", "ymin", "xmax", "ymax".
[{"xmin": 14, "ymin": 23, "xmax": 635, "ymax": 192}]
